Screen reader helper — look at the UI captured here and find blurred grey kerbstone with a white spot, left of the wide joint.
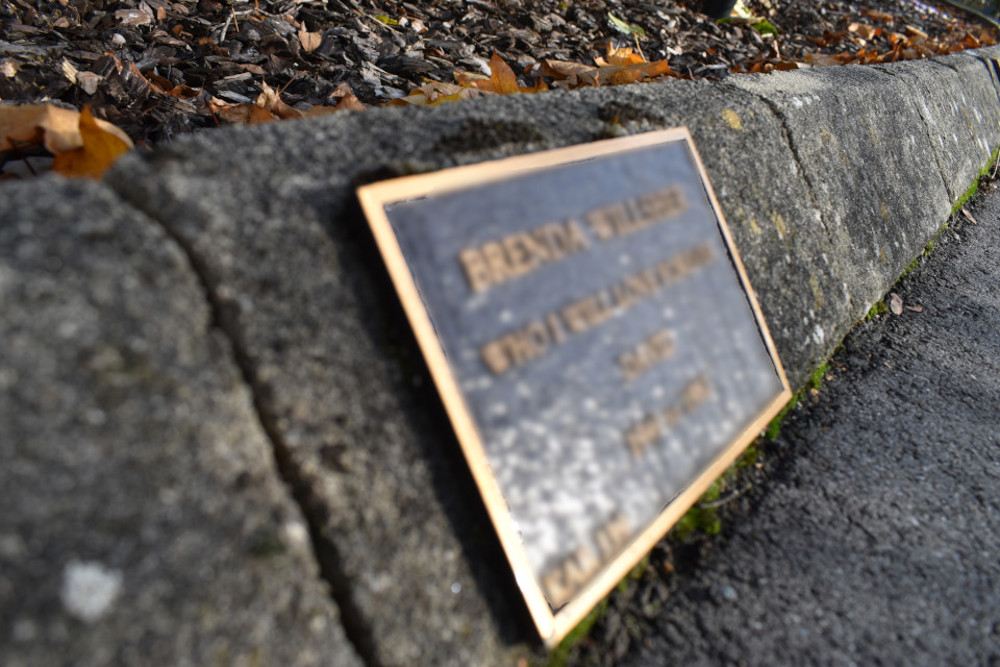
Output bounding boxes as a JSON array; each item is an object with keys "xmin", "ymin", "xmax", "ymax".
[{"xmin": 0, "ymin": 178, "xmax": 360, "ymax": 667}]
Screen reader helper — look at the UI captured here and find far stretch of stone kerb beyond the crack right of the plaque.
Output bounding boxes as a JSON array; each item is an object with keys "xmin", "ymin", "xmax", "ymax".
[{"xmin": 729, "ymin": 54, "xmax": 1000, "ymax": 341}]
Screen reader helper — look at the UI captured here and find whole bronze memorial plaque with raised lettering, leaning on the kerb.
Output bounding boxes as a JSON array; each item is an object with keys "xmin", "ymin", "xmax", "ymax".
[{"xmin": 358, "ymin": 128, "xmax": 790, "ymax": 646}]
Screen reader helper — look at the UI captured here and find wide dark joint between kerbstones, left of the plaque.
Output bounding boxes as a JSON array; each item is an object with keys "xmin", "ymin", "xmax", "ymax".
[{"xmin": 106, "ymin": 182, "xmax": 380, "ymax": 667}]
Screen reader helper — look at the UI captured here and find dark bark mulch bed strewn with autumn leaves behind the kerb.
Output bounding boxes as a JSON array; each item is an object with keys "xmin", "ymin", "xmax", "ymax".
[{"xmin": 0, "ymin": 0, "xmax": 994, "ymax": 150}]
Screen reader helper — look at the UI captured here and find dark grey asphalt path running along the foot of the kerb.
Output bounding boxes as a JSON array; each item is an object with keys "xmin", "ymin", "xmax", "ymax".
[{"xmin": 585, "ymin": 175, "xmax": 1000, "ymax": 665}]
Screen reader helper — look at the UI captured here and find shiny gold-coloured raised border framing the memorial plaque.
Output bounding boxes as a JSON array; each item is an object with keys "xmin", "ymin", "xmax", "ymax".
[{"xmin": 357, "ymin": 127, "xmax": 792, "ymax": 648}]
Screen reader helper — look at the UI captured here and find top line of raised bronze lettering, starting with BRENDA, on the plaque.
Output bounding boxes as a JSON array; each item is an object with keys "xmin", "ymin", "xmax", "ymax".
[{"xmin": 458, "ymin": 186, "xmax": 687, "ymax": 292}]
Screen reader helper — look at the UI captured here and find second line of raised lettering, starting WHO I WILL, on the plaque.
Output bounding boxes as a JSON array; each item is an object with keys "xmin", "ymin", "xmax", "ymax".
[{"xmin": 479, "ymin": 243, "xmax": 715, "ymax": 375}]
